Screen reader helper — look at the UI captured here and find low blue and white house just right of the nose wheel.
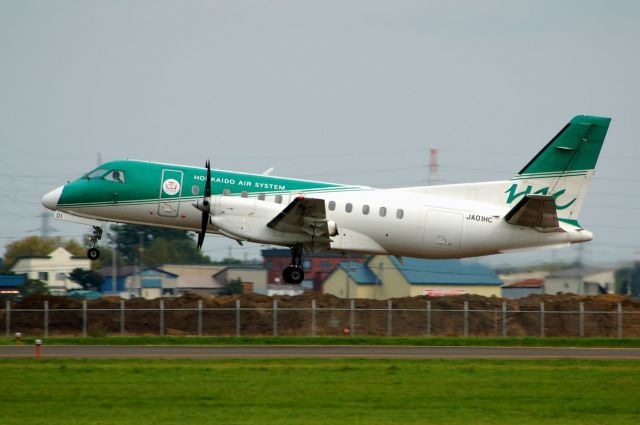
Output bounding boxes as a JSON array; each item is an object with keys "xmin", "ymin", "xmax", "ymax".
[{"xmin": 98, "ymin": 266, "xmax": 178, "ymax": 299}]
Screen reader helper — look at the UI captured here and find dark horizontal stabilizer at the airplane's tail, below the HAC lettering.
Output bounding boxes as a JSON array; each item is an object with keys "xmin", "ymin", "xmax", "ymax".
[{"xmin": 504, "ymin": 195, "xmax": 561, "ymax": 232}]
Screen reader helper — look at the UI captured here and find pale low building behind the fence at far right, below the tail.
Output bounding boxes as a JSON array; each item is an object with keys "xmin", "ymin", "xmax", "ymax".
[{"xmin": 544, "ymin": 267, "xmax": 615, "ymax": 295}]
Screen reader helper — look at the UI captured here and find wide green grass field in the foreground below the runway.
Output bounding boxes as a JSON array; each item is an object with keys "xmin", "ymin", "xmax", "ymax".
[{"xmin": 0, "ymin": 360, "xmax": 640, "ymax": 425}]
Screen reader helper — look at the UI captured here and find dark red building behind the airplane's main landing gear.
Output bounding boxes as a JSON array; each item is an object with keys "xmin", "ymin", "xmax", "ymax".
[{"xmin": 262, "ymin": 248, "xmax": 366, "ymax": 292}]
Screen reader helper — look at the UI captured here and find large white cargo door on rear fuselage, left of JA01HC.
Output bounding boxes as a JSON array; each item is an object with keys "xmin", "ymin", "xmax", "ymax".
[{"xmin": 423, "ymin": 210, "xmax": 463, "ymax": 250}]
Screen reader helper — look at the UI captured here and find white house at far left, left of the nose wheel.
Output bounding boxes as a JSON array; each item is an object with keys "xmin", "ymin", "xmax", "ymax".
[{"xmin": 9, "ymin": 247, "xmax": 91, "ymax": 295}]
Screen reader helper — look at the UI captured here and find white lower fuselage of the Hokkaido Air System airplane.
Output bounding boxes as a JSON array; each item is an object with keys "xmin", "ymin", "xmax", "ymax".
[{"xmin": 60, "ymin": 186, "xmax": 592, "ymax": 258}]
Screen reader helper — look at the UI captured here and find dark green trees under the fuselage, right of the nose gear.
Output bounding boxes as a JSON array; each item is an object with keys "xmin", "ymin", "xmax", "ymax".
[{"xmin": 109, "ymin": 224, "xmax": 211, "ymax": 266}]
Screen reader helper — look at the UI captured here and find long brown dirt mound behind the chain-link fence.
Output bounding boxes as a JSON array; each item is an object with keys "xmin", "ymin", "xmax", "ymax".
[{"xmin": 5, "ymin": 292, "xmax": 640, "ymax": 337}]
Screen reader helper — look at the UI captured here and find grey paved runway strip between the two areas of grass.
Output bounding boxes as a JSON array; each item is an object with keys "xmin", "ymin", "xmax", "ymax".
[{"xmin": 0, "ymin": 345, "xmax": 640, "ymax": 360}]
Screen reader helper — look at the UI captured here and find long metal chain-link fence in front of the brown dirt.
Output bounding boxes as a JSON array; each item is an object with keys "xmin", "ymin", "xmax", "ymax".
[{"xmin": 0, "ymin": 299, "xmax": 640, "ymax": 338}]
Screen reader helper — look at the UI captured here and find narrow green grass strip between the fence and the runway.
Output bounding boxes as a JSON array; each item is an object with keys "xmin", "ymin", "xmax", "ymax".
[{"xmin": 0, "ymin": 336, "xmax": 640, "ymax": 347}]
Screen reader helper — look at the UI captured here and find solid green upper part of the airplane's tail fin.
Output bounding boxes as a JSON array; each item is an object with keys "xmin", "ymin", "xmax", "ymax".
[{"xmin": 518, "ymin": 115, "xmax": 611, "ymax": 176}]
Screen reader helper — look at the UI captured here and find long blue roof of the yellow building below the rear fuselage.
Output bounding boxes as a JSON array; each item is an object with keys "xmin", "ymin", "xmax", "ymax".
[{"xmin": 390, "ymin": 257, "xmax": 502, "ymax": 286}]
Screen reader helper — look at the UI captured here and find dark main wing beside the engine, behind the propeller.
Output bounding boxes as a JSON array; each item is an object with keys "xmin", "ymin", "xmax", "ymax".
[{"xmin": 267, "ymin": 196, "xmax": 336, "ymax": 242}]
